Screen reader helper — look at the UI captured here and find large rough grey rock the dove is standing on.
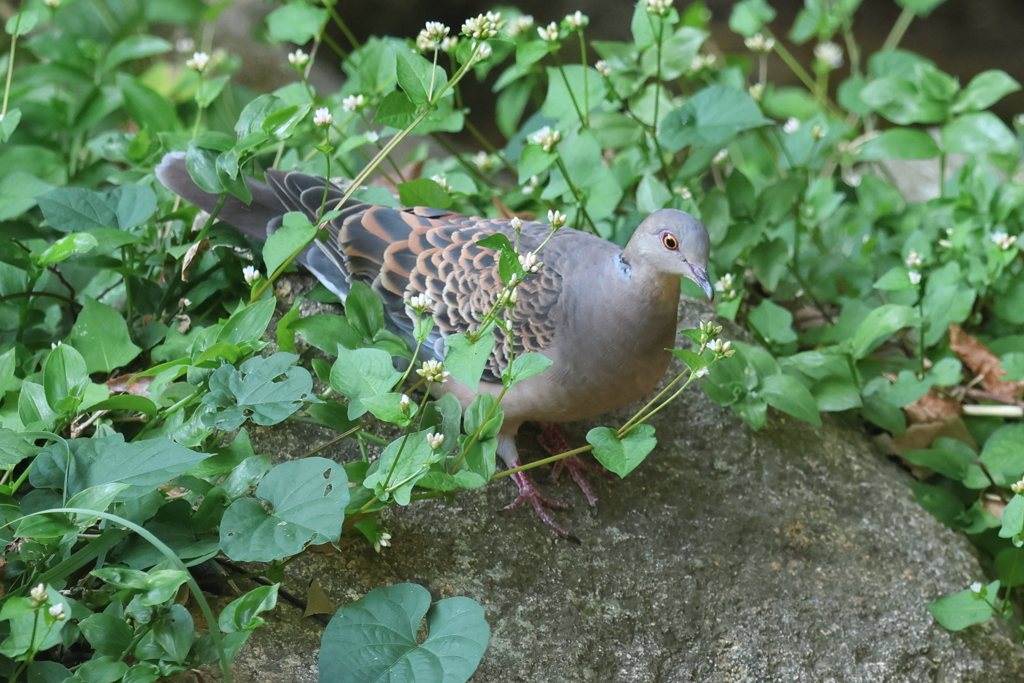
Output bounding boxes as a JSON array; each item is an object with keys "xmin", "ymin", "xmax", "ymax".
[{"xmin": 218, "ymin": 278, "xmax": 1024, "ymax": 683}]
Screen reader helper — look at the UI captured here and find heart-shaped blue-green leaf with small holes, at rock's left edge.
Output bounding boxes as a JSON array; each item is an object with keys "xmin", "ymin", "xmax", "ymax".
[{"xmin": 220, "ymin": 457, "xmax": 349, "ymax": 562}]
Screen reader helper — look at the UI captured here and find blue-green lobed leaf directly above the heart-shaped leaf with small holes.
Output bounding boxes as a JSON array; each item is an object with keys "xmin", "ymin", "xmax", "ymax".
[{"xmin": 203, "ymin": 352, "xmax": 316, "ymax": 431}]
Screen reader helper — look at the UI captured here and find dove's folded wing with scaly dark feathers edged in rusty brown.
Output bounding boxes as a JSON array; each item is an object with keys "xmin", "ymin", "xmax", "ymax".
[{"xmin": 266, "ymin": 171, "xmax": 562, "ymax": 382}]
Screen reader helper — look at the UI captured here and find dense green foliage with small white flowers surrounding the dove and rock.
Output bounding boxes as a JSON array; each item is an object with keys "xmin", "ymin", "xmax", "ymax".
[{"xmin": 0, "ymin": 0, "xmax": 1024, "ymax": 683}]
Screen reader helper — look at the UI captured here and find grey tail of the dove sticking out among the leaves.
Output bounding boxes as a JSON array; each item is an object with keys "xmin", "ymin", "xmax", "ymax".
[{"xmin": 156, "ymin": 152, "xmax": 289, "ymax": 242}]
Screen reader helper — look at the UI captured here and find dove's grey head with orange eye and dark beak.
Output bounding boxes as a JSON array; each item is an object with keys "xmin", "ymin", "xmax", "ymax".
[{"xmin": 626, "ymin": 209, "xmax": 715, "ymax": 299}]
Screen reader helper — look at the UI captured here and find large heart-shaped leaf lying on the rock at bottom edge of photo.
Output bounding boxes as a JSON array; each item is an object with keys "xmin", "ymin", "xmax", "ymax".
[{"xmin": 318, "ymin": 584, "xmax": 490, "ymax": 683}]
